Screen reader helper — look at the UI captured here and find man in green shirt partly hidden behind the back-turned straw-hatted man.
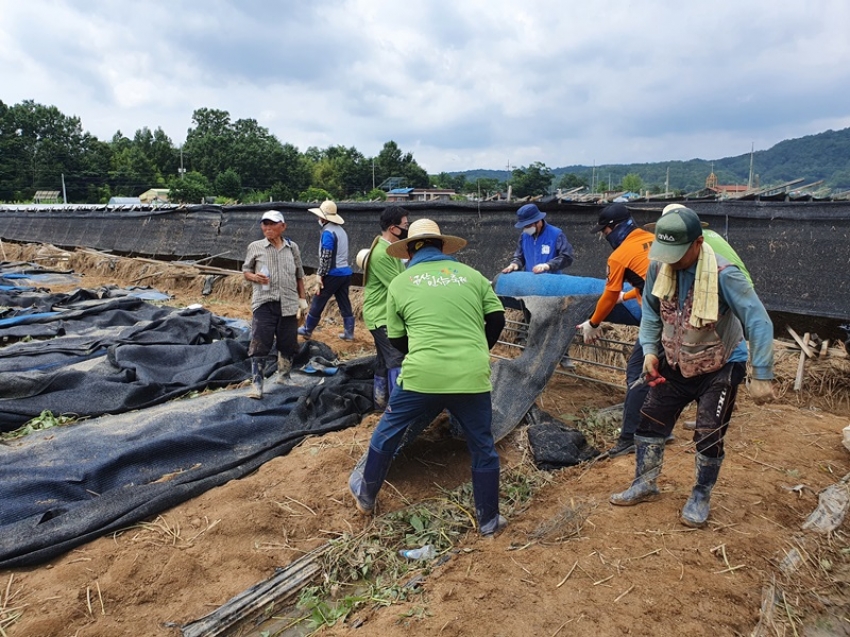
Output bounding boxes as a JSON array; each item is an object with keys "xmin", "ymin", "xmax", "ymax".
[{"xmin": 357, "ymin": 206, "xmax": 410, "ymax": 411}]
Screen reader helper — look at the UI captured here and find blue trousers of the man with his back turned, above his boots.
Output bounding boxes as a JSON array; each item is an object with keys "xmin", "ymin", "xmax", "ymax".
[{"xmin": 369, "ymin": 386, "xmax": 499, "ymax": 471}]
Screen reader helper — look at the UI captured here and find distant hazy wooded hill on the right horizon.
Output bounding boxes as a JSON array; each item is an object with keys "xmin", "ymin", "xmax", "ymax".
[{"xmin": 450, "ymin": 128, "xmax": 850, "ymax": 192}]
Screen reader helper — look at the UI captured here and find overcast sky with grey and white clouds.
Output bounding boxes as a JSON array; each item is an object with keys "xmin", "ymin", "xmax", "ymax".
[{"xmin": 0, "ymin": 0, "xmax": 850, "ymax": 173}]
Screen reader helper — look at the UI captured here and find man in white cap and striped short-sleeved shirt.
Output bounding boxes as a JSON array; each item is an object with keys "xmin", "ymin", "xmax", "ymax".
[{"xmin": 242, "ymin": 210, "xmax": 307, "ymax": 398}]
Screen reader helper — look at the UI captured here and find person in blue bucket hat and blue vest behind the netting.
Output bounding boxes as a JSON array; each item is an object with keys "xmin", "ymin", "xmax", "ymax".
[{"xmin": 502, "ymin": 203, "xmax": 573, "ymax": 274}]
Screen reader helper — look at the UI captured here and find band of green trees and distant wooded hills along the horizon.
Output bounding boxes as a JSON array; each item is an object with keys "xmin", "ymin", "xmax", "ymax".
[{"xmin": 0, "ymin": 100, "xmax": 850, "ymax": 203}]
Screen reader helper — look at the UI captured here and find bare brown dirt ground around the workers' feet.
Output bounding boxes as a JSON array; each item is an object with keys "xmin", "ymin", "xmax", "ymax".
[{"xmin": 0, "ymin": 244, "xmax": 850, "ymax": 637}]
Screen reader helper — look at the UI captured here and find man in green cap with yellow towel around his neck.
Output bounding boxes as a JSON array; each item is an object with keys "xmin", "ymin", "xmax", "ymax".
[{"xmin": 610, "ymin": 208, "xmax": 773, "ymax": 527}]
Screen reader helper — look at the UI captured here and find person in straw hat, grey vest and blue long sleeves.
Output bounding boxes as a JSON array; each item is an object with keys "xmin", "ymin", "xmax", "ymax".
[{"xmin": 298, "ymin": 201, "xmax": 354, "ymax": 341}]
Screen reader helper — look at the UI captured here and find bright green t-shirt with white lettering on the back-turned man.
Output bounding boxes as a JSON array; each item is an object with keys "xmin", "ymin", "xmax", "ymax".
[{"xmin": 387, "ymin": 259, "xmax": 504, "ymax": 394}]
